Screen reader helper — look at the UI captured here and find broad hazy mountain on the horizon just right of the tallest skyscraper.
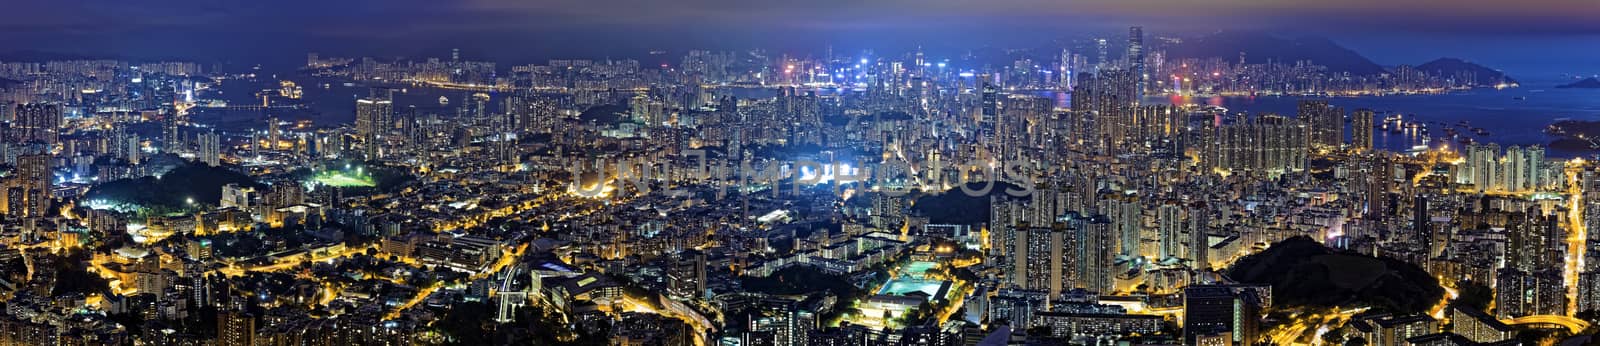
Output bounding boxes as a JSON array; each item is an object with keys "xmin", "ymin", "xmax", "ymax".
[{"xmin": 1166, "ymin": 32, "xmax": 1386, "ymax": 75}]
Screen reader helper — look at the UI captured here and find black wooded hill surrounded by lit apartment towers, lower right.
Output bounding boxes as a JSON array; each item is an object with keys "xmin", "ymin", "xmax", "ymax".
[{"xmin": 1227, "ymin": 235, "xmax": 1445, "ymax": 314}]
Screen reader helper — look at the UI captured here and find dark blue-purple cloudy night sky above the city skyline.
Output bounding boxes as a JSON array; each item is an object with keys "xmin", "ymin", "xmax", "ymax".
[{"xmin": 0, "ymin": 0, "xmax": 1600, "ymax": 74}]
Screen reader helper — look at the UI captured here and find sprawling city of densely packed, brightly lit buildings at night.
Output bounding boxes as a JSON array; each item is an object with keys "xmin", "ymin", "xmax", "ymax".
[{"xmin": 0, "ymin": 27, "xmax": 1600, "ymax": 346}]
